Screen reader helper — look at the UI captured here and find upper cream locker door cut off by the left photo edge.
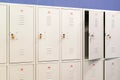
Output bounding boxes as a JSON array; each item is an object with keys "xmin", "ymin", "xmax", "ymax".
[{"xmin": 0, "ymin": 5, "xmax": 7, "ymax": 63}]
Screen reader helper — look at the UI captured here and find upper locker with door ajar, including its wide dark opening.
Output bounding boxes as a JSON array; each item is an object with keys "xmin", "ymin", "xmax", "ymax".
[{"xmin": 84, "ymin": 10, "xmax": 104, "ymax": 60}]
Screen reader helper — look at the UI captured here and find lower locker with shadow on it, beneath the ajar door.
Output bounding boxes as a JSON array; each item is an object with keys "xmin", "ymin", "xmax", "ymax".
[{"xmin": 83, "ymin": 60, "xmax": 103, "ymax": 80}]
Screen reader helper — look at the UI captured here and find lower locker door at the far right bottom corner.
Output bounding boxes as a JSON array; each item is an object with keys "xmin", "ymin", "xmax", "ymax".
[{"xmin": 105, "ymin": 59, "xmax": 120, "ymax": 80}]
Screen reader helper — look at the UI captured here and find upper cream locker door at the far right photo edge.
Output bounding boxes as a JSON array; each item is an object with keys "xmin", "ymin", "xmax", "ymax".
[{"xmin": 105, "ymin": 11, "xmax": 120, "ymax": 58}]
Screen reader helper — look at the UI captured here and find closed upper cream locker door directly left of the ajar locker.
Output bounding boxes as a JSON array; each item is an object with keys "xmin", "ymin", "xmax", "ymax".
[{"xmin": 61, "ymin": 9, "xmax": 82, "ymax": 60}]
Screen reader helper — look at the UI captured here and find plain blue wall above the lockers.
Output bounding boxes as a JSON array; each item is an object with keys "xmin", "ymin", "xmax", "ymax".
[{"xmin": 0, "ymin": 0, "xmax": 120, "ymax": 11}]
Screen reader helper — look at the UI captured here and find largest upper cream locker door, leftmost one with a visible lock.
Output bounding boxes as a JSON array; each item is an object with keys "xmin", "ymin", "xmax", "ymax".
[{"xmin": 10, "ymin": 5, "xmax": 34, "ymax": 62}]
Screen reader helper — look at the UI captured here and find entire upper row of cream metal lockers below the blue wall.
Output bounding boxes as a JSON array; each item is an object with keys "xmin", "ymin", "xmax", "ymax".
[{"xmin": 0, "ymin": 5, "xmax": 120, "ymax": 63}]
